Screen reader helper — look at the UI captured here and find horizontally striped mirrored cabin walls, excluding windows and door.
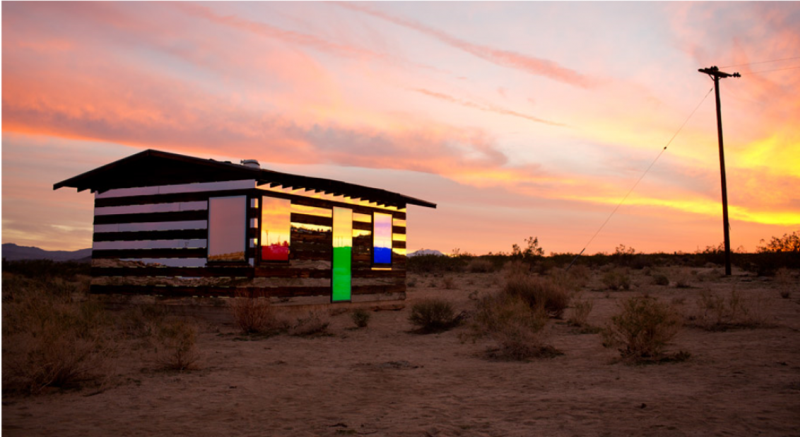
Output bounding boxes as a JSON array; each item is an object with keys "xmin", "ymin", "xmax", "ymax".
[{"xmin": 92, "ymin": 180, "xmax": 406, "ymax": 303}]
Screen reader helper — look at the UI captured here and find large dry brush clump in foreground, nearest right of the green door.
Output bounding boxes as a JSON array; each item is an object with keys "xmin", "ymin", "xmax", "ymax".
[{"xmin": 471, "ymin": 293, "xmax": 561, "ymax": 360}]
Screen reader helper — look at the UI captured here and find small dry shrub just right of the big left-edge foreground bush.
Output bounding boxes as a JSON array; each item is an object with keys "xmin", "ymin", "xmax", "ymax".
[{"xmin": 156, "ymin": 320, "xmax": 199, "ymax": 371}]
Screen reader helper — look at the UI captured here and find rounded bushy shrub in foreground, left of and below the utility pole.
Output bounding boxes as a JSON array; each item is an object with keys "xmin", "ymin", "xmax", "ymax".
[{"xmin": 603, "ymin": 296, "xmax": 681, "ymax": 361}]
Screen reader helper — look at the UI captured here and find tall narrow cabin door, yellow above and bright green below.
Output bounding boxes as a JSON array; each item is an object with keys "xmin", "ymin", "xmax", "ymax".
[{"xmin": 331, "ymin": 207, "xmax": 353, "ymax": 302}]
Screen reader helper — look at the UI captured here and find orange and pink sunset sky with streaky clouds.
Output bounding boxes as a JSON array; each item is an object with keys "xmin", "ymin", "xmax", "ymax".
[{"xmin": 2, "ymin": 2, "xmax": 800, "ymax": 254}]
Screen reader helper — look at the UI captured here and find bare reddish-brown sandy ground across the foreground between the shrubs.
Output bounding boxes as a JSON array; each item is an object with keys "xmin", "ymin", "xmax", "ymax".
[{"xmin": 2, "ymin": 269, "xmax": 800, "ymax": 436}]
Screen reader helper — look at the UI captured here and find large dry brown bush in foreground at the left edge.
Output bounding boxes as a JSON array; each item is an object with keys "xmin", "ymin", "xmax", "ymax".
[{"xmin": 3, "ymin": 281, "xmax": 113, "ymax": 393}]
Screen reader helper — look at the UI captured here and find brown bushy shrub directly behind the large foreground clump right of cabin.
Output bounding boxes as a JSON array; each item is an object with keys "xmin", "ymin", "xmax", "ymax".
[{"xmin": 503, "ymin": 273, "xmax": 570, "ymax": 318}]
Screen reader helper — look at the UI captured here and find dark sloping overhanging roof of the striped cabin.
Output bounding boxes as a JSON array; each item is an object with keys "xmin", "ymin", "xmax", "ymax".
[{"xmin": 53, "ymin": 149, "xmax": 436, "ymax": 208}]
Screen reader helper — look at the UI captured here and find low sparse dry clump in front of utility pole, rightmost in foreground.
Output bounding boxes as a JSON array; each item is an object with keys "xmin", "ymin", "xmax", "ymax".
[{"xmin": 689, "ymin": 290, "xmax": 765, "ymax": 331}]
